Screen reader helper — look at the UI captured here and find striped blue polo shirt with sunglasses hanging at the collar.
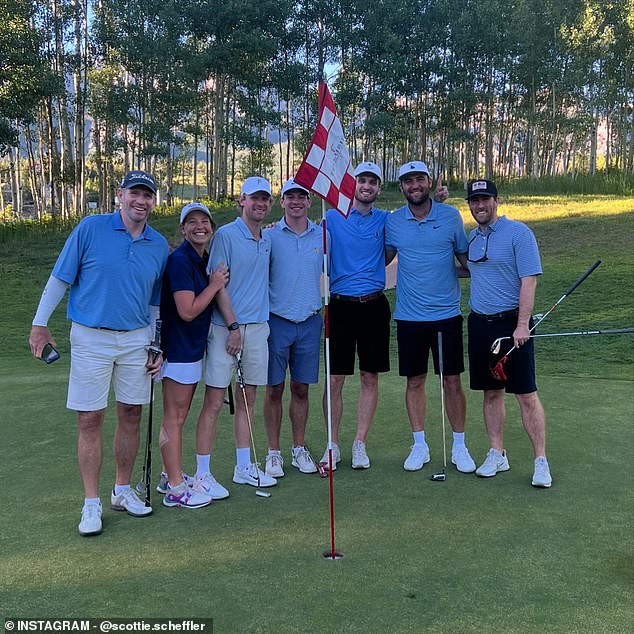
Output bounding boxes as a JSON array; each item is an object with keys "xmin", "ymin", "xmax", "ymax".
[{"xmin": 468, "ymin": 216, "xmax": 542, "ymax": 315}]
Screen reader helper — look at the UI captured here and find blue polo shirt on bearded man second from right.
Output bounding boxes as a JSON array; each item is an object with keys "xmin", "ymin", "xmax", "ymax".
[{"xmin": 385, "ymin": 201, "xmax": 467, "ymax": 321}]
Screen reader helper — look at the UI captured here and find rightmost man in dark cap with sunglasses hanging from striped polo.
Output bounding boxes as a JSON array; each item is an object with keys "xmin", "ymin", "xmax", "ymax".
[{"xmin": 467, "ymin": 180, "xmax": 552, "ymax": 488}]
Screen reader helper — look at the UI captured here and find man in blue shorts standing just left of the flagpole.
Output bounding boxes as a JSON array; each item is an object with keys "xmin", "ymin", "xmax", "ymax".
[{"xmin": 264, "ymin": 179, "xmax": 324, "ymax": 478}]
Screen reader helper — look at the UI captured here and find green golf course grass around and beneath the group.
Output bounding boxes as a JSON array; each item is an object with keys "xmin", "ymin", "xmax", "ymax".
[{"xmin": 0, "ymin": 189, "xmax": 634, "ymax": 633}]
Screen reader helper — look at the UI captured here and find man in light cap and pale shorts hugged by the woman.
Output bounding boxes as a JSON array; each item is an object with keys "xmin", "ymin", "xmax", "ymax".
[{"xmin": 194, "ymin": 176, "xmax": 277, "ymax": 492}]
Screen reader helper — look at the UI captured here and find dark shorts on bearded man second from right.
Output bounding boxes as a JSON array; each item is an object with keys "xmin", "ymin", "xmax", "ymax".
[{"xmin": 396, "ymin": 315, "xmax": 464, "ymax": 377}]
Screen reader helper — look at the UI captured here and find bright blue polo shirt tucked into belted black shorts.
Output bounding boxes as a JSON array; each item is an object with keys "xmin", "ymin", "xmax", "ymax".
[{"xmin": 326, "ymin": 207, "xmax": 390, "ymax": 297}]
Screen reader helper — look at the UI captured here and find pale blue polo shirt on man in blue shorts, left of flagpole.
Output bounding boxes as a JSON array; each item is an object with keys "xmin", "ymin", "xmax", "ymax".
[{"xmin": 265, "ymin": 218, "xmax": 324, "ymax": 321}]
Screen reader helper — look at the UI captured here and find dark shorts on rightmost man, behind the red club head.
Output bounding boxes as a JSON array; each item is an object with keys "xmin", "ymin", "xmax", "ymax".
[{"xmin": 467, "ymin": 313, "xmax": 537, "ymax": 394}]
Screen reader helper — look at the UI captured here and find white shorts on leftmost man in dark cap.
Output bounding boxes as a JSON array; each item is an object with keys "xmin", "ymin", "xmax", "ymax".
[{"xmin": 66, "ymin": 322, "xmax": 152, "ymax": 412}]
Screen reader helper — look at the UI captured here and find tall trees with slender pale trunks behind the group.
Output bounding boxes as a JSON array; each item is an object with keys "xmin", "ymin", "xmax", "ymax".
[{"xmin": 0, "ymin": 0, "xmax": 634, "ymax": 217}]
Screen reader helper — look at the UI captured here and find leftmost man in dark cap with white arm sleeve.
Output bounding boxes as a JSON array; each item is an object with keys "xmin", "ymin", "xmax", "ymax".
[{"xmin": 29, "ymin": 171, "xmax": 169, "ymax": 535}]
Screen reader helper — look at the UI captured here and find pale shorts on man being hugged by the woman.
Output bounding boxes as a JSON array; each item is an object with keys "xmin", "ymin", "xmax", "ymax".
[{"xmin": 205, "ymin": 321, "xmax": 269, "ymax": 387}]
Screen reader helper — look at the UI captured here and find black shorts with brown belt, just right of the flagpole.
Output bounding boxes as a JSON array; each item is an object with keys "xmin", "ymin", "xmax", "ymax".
[{"xmin": 328, "ymin": 294, "xmax": 391, "ymax": 375}]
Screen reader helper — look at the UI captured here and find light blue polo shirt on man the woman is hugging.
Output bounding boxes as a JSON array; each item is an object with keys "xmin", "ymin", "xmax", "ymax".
[{"xmin": 207, "ymin": 217, "xmax": 271, "ymax": 326}]
